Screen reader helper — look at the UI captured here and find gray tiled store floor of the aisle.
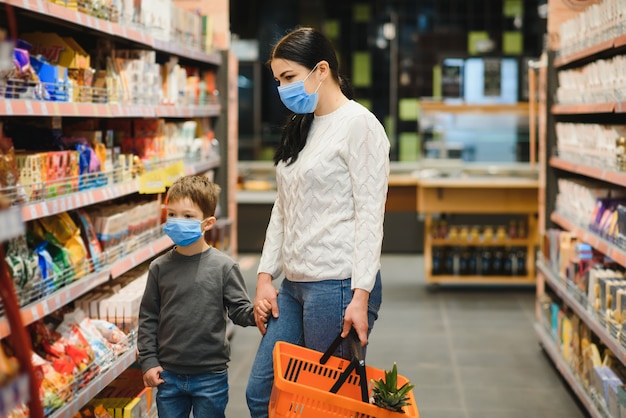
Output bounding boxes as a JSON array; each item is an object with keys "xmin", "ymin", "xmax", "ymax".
[{"xmin": 227, "ymin": 255, "xmax": 587, "ymax": 418}]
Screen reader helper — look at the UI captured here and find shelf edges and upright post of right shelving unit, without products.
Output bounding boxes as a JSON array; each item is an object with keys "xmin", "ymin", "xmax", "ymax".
[{"xmin": 535, "ymin": 0, "xmax": 626, "ymax": 418}]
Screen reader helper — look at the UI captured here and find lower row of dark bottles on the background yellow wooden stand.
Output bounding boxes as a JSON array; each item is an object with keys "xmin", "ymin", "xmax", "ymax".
[{"xmin": 432, "ymin": 247, "xmax": 527, "ymax": 276}]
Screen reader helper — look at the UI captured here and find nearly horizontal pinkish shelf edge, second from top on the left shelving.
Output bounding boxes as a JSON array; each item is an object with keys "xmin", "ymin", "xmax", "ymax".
[{"xmin": 0, "ymin": 99, "xmax": 222, "ymax": 118}]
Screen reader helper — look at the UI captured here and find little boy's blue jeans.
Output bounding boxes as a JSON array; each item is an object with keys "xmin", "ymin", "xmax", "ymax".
[{"xmin": 157, "ymin": 370, "xmax": 228, "ymax": 418}]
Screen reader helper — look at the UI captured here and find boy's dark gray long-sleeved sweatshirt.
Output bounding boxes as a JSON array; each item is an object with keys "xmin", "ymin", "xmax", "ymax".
[{"xmin": 137, "ymin": 247, "xmax": 255, "ymax": 374}]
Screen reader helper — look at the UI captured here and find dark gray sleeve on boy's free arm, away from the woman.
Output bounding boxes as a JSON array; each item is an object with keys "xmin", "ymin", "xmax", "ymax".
[{"xmin": 137, "ymin": 265, "xmax": 161, "ymax": 373}]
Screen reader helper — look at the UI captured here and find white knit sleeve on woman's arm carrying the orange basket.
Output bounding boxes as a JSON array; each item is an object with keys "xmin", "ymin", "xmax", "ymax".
[{"xmin": 344, "ymin": 115, "xmax": 389, "ymax": 292}]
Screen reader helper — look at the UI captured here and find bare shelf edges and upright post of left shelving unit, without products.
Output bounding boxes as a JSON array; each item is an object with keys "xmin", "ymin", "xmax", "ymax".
[{"xmin": 0, "ymin": 0, "xmax": 237, "ymax": 417}]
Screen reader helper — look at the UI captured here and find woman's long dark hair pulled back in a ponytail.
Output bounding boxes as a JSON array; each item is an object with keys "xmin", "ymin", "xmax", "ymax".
[{"xmin": 267, "ymin": 27, "xmax": 354, "ymax": 165}]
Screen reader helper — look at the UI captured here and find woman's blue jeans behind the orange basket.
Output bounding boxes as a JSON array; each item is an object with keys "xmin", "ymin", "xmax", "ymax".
[{"xmin": 246, "ymin": 272, "xmax": 382, "ymax": 418}]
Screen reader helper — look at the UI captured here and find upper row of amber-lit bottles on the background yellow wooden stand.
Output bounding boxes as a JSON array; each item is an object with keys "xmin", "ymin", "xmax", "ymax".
[{"xmin": 430, "ymin": 219, "xmax": 527, "ymax": 242}]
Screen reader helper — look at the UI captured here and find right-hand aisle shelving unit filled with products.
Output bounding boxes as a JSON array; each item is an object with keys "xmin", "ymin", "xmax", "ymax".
[{"xmin": 535, "ymin": 0, "xmax": 626, "ymax": 417}]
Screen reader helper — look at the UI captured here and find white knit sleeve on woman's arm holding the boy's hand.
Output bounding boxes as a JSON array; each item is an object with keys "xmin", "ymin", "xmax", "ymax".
[{"xmin": 257, "ymin": 193, "xmax": 284, "ymax": 279}]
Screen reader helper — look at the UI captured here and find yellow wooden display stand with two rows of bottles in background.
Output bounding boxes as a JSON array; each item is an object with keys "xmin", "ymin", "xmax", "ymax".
[{"xmin": 417, "ymin": 176, "xmax": 538, "ymax": 285}]
